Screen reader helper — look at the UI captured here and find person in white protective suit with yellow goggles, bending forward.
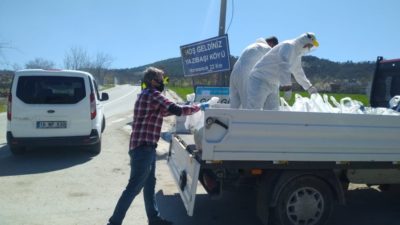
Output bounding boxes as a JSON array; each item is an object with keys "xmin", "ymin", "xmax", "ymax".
[{"xmin": 246, "ymin": 33, "xmax": 319, "ymax": 110}]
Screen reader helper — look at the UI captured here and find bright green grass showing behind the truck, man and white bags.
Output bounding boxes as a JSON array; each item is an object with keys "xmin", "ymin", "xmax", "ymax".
[{"xmin": 168, "ymin": 87, "xmax": 370, "ymax": 106}]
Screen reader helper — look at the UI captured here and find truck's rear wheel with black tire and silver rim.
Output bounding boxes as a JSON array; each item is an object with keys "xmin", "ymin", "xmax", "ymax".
[{"xmin": 272, "ymin": 176, "xmax": 333, "ymax": 225}]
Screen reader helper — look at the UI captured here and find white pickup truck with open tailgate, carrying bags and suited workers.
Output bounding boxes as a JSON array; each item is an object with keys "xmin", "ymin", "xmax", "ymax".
[{"xmin": 168, "ymin": 57, "xmax": 400, "ymax": 225}]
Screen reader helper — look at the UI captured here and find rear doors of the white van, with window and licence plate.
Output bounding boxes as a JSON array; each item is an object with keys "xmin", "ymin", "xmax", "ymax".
[{"xmin": 10, "ymin": 72, "xmax": 91, "ymax": 137}]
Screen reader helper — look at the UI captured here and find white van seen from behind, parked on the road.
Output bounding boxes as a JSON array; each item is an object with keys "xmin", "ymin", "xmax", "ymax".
[{"xmin": 7, "ymin": 69, "xmax": 108, "ymax": 155}]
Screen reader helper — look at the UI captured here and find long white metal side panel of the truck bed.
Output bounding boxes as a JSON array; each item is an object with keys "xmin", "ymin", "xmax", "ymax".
[{"xmin": 201, "ymin": 108, "xmax": 400, "ymax": 164}]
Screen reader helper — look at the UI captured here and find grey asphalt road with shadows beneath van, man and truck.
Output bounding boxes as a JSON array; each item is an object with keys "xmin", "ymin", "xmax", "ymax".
[{"xmin": 0, "ymin": 85, "xmax": 400, "ymax": 225}]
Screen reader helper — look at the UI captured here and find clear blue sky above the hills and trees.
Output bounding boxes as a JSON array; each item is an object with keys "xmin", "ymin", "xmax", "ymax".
[{"xmin": 0, "ymin": 0, "xmax": 400, "ymax": 69}]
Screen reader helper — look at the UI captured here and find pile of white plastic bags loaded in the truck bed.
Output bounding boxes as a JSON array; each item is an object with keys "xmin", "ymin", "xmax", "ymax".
[{"xmin": 280, "ymin": 94, "xmax": 400, "ymax": 116}]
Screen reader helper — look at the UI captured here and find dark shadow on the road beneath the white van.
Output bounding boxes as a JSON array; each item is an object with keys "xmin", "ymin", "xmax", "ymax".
[{"xmin": 0, "ymin": 145, "xmax": 93, "ymax": 177}]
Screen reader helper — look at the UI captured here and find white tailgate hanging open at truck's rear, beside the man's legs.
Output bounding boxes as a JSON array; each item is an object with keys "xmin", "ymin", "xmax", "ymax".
[{"xmin": 167, "ymin": 135, "xmax": 200, "ymax": 216}]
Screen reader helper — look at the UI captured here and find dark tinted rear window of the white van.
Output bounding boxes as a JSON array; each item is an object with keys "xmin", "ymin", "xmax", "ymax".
[{"xmin": 17, "ymin": 76, "xmax": 86, "ymax": 104}]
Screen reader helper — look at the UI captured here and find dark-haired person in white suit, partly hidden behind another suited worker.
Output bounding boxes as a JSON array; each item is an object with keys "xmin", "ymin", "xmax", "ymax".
[{"xmin": 229, "ymin": 36, "xmax": 278, "ymax": 108}]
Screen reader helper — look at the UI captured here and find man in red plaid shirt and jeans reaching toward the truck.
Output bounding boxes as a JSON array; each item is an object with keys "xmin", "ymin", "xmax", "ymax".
[{"xmin": 108, "ymin": 67, "xmax": 207, "ymax": 225}]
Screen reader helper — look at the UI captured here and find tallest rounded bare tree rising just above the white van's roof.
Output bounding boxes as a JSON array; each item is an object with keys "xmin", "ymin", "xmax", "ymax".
[{"xmin": 64, "ymin": 47, "xmax": 90, "ymax": 70}]
